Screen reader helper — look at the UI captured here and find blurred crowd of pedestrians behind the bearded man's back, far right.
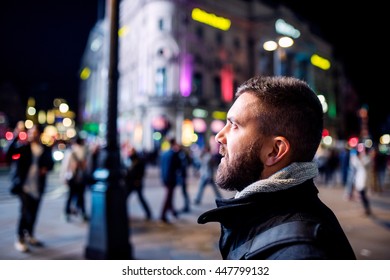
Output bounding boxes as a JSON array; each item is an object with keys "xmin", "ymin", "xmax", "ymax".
[{"xmin": 315, "ymin": 143, "xmax": 390, "ymax": 215}]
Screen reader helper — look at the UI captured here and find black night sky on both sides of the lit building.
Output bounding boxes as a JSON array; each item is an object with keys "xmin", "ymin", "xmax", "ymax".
[{"xmin": 0, "ymin": 0, "xmax": 390, "ymax": 138}]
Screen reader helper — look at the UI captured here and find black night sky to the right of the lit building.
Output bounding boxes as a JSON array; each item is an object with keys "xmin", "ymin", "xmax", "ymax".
[{"xmin": 278, "ymin": 0, "xmax": 390, "ymax": 137}]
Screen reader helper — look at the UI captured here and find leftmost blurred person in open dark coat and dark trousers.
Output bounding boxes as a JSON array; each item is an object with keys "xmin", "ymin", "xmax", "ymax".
[{"xmin": 6, "ymin": 125, "xmax": 54, "ymax": 252}]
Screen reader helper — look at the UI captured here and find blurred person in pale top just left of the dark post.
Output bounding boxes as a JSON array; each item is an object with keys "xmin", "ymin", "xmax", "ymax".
[{"xmin": 61, "ymin": 136, "xmax": 89, "ymax": 222}]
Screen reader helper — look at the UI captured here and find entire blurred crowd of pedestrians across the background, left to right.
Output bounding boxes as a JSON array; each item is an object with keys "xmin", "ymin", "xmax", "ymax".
[{"xmin": 7, "ymin": 119, "xmax": 390, "ymax": 252}]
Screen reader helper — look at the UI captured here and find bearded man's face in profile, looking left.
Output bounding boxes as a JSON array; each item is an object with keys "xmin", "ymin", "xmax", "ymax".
[{"xmin": 215, "ymin": 93, "xmax": 264, "ymax": 191}]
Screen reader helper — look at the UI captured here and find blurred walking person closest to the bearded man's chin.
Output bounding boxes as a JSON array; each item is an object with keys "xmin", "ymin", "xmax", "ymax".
[{"xmin": 194, "ymin": 146, "xmax": 222, "ymax": 205}]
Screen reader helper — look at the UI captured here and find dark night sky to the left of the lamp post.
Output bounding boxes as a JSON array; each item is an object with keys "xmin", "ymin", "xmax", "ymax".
[{"xmin": 0, "ymin": 0, "xmax": 98, "ymax": 114}]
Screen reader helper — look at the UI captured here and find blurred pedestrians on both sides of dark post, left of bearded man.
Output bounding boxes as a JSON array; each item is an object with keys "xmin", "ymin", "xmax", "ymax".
[{"xmin": 6, "ymin": 122, "xmax": 225, "ymax": 252}]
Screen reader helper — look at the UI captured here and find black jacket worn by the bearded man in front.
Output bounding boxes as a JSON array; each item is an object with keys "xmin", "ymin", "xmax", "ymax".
[{"xmin": 198, "ymin": 180, "xmax": 356, "ymax": 260}]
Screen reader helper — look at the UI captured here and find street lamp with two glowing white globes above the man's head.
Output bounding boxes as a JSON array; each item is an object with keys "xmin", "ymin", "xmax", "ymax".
[{"xmin": 263, "ymin": 36, "xmax": 294, "ymax": 75}]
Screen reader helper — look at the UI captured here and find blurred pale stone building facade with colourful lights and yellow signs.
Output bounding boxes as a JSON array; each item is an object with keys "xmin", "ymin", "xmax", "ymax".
[{"xmin": 79, "ymin": 0, "xmax": 342, "ymax": 151}]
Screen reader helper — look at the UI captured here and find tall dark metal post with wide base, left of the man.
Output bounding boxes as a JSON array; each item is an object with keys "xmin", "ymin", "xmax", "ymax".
[{"xmin": 85, "ymin": 0, "xmax": 133, "ymax": 260}]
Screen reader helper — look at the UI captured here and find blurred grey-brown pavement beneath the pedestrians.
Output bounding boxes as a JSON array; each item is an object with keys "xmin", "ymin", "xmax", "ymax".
[{"xmin": 0, "ymin": 166, "xmax": 390, "ymax": 260}]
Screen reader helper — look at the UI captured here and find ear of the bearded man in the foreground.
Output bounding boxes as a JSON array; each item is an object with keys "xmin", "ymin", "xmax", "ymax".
[{"xmin": 264, "ymin": 136, "xmax": 290, "ymax": 166}]
